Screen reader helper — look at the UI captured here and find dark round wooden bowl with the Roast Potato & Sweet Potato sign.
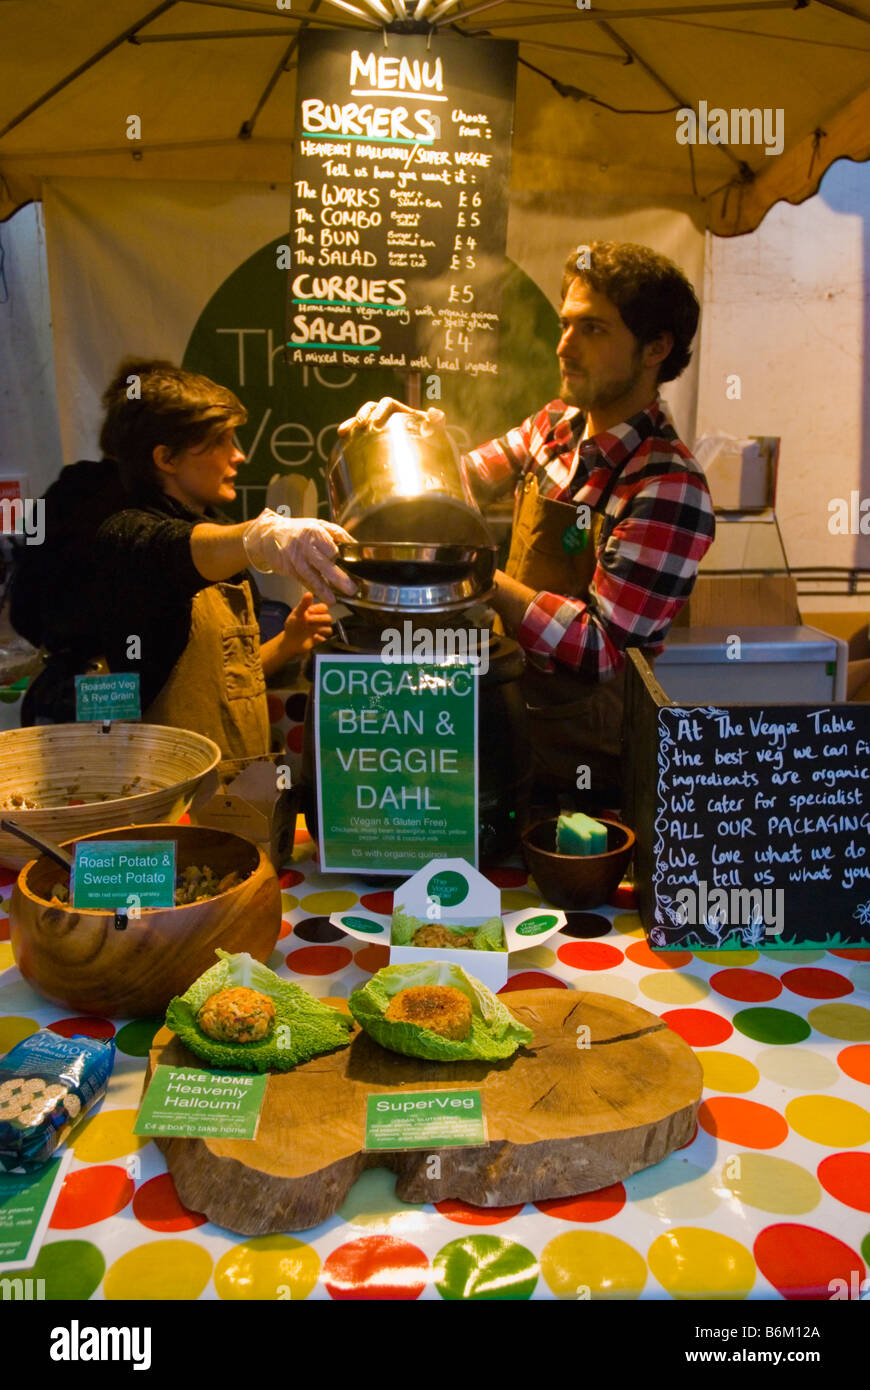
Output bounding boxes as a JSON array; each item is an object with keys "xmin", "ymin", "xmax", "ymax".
[{"xmin": 10, "ymin": 824, "xmax": 281, "ymax": 1017}]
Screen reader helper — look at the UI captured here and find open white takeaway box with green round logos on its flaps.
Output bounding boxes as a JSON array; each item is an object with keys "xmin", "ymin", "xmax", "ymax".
[{"xmin": 329, "ymin": 859, "xmax": 566, "ymax": 990}]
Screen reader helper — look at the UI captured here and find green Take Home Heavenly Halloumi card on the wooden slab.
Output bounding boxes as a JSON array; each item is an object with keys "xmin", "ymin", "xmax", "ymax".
[{"xmin": 133, "ymin": 1066, "xmax": 268, "ymax": 1138}]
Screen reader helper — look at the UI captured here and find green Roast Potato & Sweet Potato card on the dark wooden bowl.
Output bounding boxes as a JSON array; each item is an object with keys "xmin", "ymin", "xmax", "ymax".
[{"xmin": 69, "ymin": 840, "xmax": 175, "ymax": 917}]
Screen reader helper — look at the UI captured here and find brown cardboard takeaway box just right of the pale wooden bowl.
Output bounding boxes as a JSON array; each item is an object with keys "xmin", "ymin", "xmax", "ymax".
[{"xmin": 190, "ymin": 758, "xmax": 299, "ymax": 869}]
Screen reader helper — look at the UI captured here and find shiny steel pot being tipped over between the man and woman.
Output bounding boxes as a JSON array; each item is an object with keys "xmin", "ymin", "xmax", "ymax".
[{"xmin": 327, "ymin": 413, "xmax": 493, "ymax": 546}]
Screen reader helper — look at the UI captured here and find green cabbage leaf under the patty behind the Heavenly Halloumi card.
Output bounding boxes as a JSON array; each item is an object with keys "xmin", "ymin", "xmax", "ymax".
[{"xmin": 167, "ymin": 949, "xmax": 353, "ymax": 1072}]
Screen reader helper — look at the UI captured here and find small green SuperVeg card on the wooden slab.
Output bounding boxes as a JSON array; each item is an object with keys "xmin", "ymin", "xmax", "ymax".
[{"xmin": 366, "ymin": 1091, "xmax": 486, "ymax": 1150}]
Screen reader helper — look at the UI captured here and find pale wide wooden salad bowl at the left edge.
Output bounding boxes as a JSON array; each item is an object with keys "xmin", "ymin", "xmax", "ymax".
[{"xmin": 0, "ymin": 723, "xmax": 222, "ymax": 869}]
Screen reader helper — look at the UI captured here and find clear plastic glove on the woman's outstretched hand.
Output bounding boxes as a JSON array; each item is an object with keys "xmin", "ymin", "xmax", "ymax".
[{"xmin": 242, "ymin": 507, "xmax": 356, "ymax": 603}]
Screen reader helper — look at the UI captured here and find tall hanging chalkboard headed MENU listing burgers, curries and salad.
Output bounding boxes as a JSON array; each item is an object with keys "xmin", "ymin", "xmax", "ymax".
[{"xmin": 285, "ymin": 29, "xmax": 517, "ymax": 375}]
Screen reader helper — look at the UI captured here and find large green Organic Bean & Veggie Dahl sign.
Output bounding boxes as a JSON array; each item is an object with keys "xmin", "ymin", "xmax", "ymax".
[{"xmin": 314, "ymin": 655, "xmax": 478, "ymax": 873}]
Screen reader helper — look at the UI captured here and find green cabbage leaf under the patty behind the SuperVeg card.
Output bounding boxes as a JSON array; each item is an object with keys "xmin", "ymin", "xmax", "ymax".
[{"xmin": 347, "ymin": 960, "xmax": 534, "ymax": 1062}]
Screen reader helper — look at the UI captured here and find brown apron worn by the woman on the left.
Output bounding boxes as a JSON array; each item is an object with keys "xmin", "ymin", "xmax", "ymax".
[{"xmin": 142, "ymin": 580, "xmax": 271, "ymax": 758}]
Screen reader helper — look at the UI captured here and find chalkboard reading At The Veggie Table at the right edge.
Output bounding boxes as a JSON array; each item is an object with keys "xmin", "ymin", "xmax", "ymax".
[{"xmin": 649, "ymin": 705, "xmax": 870, "ymax": 948}]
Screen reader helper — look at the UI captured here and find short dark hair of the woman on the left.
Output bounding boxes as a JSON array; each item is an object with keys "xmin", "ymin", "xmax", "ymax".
[{"xmin": 100, "ymin": 357, "xmax": 247, "ymax": 493}]
